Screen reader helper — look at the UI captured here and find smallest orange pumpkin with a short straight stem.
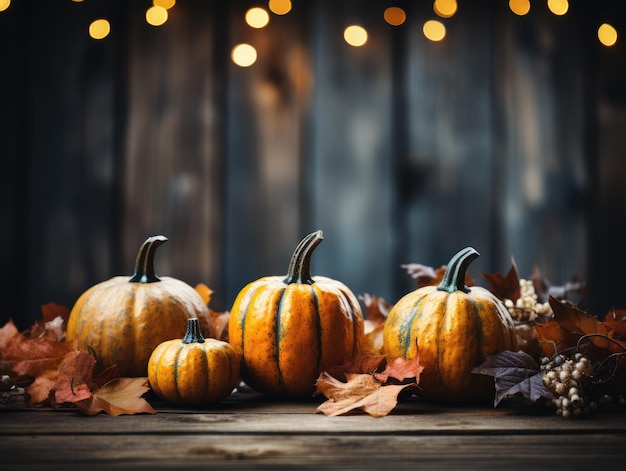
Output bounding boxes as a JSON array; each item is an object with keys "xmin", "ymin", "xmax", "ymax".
[{"xmin": 148, "ymin": 318, "xmax": 240, "ymax": 405}]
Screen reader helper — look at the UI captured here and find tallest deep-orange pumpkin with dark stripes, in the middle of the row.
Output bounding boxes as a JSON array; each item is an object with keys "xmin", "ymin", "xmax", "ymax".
[{"xmin": 228, "ymin": 231, "xmax": 364, "ymax": 398}]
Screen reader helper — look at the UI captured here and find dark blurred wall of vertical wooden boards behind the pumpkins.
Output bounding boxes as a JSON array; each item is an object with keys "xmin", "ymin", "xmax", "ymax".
[{"xmin": 0, "ymin": 0, "xmax": 626, "ymax": 328}]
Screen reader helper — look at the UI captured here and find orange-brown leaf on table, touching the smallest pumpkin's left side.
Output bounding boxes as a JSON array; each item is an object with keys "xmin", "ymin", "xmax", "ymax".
[{"xmin": 77, "ymin": 378, "xmax": 156, "ymax": 416}]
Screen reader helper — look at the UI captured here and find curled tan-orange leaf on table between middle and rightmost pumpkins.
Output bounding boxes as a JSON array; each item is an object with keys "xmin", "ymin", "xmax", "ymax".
[{"xmin": 316, "ymin": 372, "xmax": 415, "ymax": 417}]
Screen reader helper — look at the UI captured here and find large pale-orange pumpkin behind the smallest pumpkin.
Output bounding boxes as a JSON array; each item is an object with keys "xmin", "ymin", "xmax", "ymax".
[{"xmin": 66, "ymin": 236, "xmax": 212, "ymax": 376}]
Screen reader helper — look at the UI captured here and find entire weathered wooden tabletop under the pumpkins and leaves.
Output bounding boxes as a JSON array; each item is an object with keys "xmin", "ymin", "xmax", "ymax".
[{"xmin": 0, "ymin": 393, "xmax": 626, "ymax": 471}]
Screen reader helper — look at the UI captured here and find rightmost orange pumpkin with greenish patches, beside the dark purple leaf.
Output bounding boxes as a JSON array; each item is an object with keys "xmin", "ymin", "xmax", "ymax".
[{"xmin": 383, "ymin": 247, "xmax": 517, "ymax": 403}]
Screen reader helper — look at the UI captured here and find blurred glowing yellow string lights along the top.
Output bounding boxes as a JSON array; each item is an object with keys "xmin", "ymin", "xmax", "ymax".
[{"xmin": 0, "ymin": 0, "xmax": 618, "ymax": 67}]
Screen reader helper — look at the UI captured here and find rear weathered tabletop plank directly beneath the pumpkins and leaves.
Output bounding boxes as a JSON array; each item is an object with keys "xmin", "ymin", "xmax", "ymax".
[{"xmin": 0, "ymin": 402, "xmax": 626, "ymax": 437}]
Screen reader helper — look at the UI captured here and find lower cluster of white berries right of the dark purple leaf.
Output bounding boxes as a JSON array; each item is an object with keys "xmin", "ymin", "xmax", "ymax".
[{"xmin": 541, "ymin": 353, "xmax": 598, "ymax": 417}]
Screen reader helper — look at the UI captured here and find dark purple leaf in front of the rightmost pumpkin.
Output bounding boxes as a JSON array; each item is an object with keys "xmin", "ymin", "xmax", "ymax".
[{"xmin": 472, "ymin": 350, "xmax": 555, "ymax": 407}]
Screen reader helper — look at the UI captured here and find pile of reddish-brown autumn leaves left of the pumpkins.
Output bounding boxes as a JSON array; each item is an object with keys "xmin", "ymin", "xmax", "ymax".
[{"xmin": 0, "ymin": 304, "xmax": 155, "ymax": 415}]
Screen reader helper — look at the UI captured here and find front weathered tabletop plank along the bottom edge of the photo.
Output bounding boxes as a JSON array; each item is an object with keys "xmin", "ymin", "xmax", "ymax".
[{"xmin": 0, "ymin": 434, "xmax": 626, "ymax": 470}]
